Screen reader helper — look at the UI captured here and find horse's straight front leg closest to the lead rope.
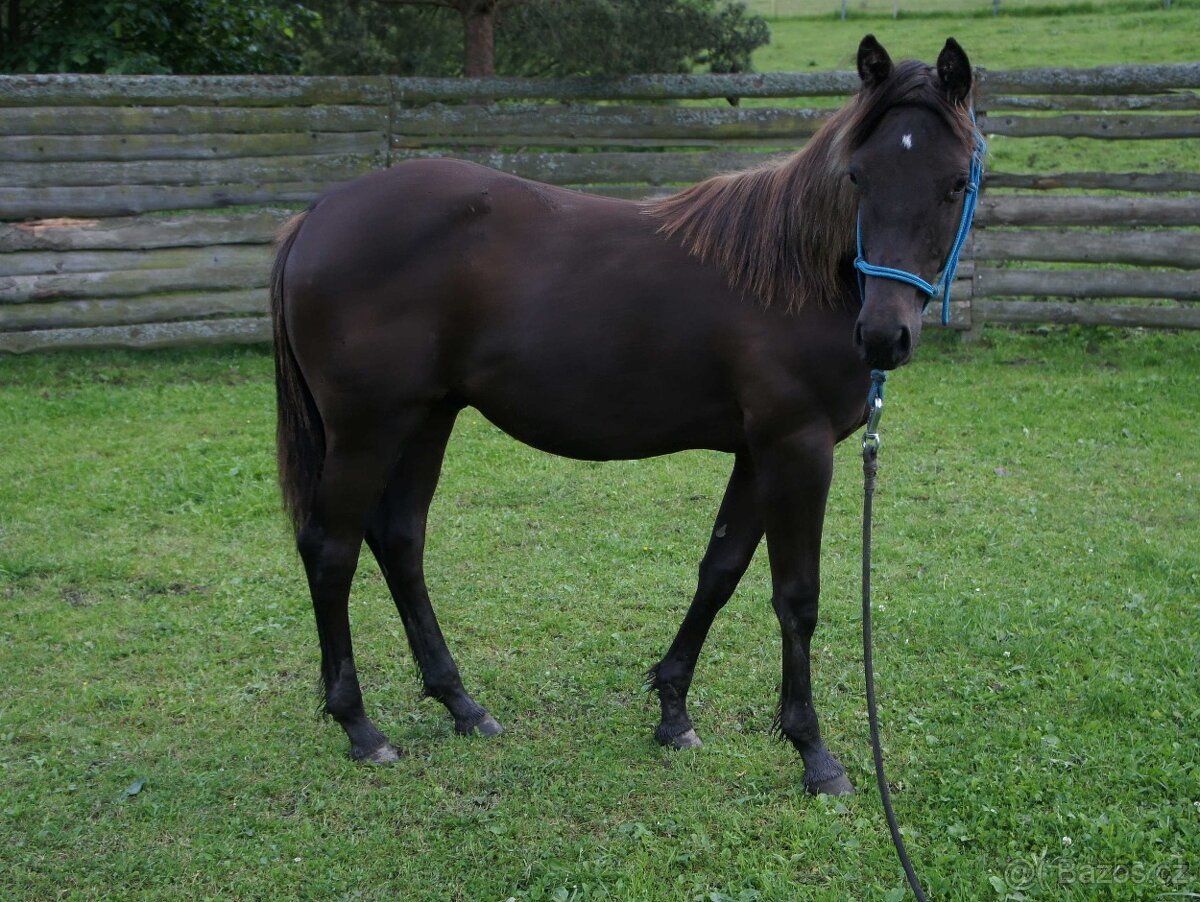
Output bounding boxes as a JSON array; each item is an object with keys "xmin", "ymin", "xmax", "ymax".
[{"xmin": 755, "ymin": 426, "xmax": 854, "ymax": 795}]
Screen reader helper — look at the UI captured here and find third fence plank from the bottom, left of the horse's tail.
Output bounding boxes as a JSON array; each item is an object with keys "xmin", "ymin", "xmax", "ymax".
[{"xmin": 0, "ymin": 264, "xmax": 270, "ymax": 305}]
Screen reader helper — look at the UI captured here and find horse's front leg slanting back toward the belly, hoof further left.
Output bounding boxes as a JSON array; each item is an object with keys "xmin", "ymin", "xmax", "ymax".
[{"xmin": 650, "ymin": 455, "xmax": 763, "ymax": 748}]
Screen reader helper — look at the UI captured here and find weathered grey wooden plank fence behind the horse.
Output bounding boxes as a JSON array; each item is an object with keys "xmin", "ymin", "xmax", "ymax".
[{"xmin": 0, "ymin": 64, "xmax": 1200, "ymax": 351}]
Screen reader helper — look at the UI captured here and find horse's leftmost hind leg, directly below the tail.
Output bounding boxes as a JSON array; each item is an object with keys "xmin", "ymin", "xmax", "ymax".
[{"xmin": 296, "ymin": 415, "xmax": 416, "ymax": 764}]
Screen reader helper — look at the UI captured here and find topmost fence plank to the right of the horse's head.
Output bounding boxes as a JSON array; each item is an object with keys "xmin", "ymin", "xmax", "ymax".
[{"xmin": 976, "ymin": 62, "xmax": 1200, "ymax": 98}]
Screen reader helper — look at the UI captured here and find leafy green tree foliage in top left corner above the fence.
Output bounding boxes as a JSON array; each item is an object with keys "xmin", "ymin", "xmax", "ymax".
[{"xmin": 0, "ymin": 0, "xmax": 312, "ymax": 74}]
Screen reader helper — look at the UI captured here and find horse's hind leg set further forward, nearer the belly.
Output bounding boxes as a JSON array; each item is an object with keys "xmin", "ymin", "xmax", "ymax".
[{"xmin": 366, "ymin": 407, "xmax": 502, "ymax": 736}]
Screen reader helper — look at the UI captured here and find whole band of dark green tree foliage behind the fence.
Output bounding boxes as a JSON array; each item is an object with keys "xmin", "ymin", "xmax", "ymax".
[{"xmin": 0, "ymin": 0, "xmax": 770, "ymax": 76}]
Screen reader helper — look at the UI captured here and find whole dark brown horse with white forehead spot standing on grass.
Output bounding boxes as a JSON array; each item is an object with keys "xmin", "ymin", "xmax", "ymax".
[{"xmin": 271, "ymin": 36, "xmax": 972, "ymax": 793}]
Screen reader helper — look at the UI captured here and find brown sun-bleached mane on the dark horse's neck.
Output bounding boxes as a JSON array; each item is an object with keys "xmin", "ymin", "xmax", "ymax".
[{"xmin": 644, "ymin": 60, "xmax": 974, "ymax": 309}]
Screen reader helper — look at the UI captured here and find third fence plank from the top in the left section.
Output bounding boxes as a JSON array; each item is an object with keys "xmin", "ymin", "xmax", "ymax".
[{"xmin": 0, "ymin": 130, "xmax": 388, "ymax": 163}]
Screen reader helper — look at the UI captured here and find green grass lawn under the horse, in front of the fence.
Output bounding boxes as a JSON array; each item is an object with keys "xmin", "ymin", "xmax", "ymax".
[{"xmin": 0, "ymin": 331, "xmax": 1200, "ymax": 900}]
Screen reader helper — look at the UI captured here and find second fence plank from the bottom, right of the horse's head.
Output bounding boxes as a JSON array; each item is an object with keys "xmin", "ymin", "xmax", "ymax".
[{"xmin": 974, "ymin": 266, "xmax": 1200, "ymax": 301}]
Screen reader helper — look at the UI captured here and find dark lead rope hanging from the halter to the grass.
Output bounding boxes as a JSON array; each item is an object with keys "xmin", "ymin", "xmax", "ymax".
[{"xmin": 863, "ymin": 369, "xmax": 926, "ymax": 902}]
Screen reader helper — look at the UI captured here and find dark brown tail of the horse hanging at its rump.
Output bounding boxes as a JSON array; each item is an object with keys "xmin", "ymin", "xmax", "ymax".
[{"xmin": 271, "ymin": 210, "xmax": 325, "ymax": 531}]
